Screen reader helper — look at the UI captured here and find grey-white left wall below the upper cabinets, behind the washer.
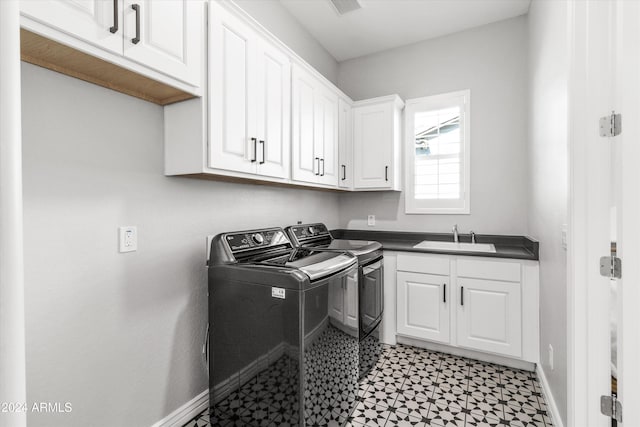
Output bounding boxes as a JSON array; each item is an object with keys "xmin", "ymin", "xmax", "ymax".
[{"xmin": 22, "ymin": 64, "xmax": 338, "ymax": 427}]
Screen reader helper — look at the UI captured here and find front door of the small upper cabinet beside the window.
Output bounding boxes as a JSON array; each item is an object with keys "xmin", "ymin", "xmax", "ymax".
[{"xmin": 353, "ymin": 104, "xmax": 394, "ymax": 189}]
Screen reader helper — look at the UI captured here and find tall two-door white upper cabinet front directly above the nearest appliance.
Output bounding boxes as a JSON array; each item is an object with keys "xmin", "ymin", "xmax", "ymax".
[{"xmin": 208, "ymin": 2, "xmax": 291, "ymax": 178}]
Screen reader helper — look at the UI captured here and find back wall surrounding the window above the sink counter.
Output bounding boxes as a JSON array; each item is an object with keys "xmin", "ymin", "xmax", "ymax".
[{"xmin": 338, "ymin": 17, "xmax": 527, "ymax": 234}]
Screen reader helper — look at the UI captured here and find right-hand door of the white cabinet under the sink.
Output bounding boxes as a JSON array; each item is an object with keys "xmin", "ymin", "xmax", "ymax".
[{"xmin": 456, "ymin": 278, "xmax": 522, "ymax": 357}]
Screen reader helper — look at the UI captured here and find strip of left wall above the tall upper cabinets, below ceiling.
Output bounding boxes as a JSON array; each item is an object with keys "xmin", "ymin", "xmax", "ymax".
[{"xmin": 235, "ymin": 0, "xmax": 338, "ymax": 84}]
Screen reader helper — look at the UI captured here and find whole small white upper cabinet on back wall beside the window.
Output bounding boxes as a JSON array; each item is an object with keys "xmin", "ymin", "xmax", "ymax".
[{"xmin": 353, "ymin": 95, "xmax": 404, "ymax": 190}]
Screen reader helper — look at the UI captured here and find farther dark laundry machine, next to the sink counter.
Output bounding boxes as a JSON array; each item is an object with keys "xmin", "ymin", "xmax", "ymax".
[{"xmin": 285, "ymin": 223, "xmax": 384, "ymax": 377}]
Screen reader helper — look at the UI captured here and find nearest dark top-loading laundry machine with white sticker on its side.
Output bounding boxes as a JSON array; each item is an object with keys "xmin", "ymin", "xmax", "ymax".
[{"xmin": 208, "ymin": 228, "xmax": 359, "ymax": 426}]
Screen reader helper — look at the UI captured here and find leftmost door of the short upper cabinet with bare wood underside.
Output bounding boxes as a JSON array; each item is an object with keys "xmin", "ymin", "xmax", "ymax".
[{"xmin": 20, "ymin": 0, "xmax": 124, "ymax": 55}]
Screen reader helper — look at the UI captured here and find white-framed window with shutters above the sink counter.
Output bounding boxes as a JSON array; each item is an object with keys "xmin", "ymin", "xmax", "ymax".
[{"xmin": 405, "ymin": 90, "xmax": 470, "ymax": 214}]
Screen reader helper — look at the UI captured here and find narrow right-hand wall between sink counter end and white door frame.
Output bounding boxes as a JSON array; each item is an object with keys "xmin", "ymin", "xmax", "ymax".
[{"xmin": 527, "ymin": 0, "xmax": 569, "ymax": 425}]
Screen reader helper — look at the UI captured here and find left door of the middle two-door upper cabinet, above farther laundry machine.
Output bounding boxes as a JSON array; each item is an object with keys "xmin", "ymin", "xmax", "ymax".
[{"xmin": 291, "ymin": 65, "xmax": 320, "ymax": 183}]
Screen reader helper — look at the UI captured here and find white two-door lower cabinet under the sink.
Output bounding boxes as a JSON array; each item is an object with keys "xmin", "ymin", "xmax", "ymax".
[{"xmin": 395, "ymin": 253, "xmax": 539, "ymax": 362}]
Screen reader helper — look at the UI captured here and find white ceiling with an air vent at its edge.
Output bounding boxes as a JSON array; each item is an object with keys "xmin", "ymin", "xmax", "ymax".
[{"xmin": 280, "ymin": 0, "xmax": 531, "ymax": 61}]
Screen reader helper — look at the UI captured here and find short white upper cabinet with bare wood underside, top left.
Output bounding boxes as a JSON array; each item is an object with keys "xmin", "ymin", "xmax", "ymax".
[{"xmin": 20, "ymin": 0, "xmax": 205, "ymax": 105}]
